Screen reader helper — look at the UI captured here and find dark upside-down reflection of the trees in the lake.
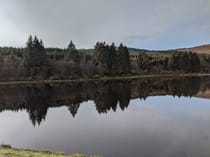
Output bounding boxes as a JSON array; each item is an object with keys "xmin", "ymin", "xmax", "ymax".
[{"xmin": 0, "ymin": 77, "xmax": 210, "ymax": 125}]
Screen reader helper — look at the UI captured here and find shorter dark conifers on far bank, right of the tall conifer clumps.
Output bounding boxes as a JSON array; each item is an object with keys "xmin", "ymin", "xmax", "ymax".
[{"xmin": 137, "ymin": 52, "xmax": 202, "ymax": 73}]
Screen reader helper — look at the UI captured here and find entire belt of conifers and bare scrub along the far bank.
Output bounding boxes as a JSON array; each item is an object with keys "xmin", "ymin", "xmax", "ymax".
[{"xmin": 0, "ymin": 36, "xmax": 210, "ymax": 80}]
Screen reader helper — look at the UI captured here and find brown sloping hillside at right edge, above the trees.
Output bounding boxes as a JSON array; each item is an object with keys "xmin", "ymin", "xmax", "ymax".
[{"xmin": 177, "ymin": 44, "xmax": 210, "ymax": 54}]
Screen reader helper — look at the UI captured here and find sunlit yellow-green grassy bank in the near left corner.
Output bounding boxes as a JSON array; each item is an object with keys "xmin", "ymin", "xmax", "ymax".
[{"xmin": 0, "ymin": 145, "xmax": 97, "ymax": 157}]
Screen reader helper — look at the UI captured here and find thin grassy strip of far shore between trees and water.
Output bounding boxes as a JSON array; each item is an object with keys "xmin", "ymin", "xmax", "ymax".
[{"xmin": 0, "ymin": 73, "xmax": 210, "ymax": 85}]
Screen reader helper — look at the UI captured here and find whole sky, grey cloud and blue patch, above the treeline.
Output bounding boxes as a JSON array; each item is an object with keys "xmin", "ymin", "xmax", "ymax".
[{"xmin": 0, "ymin": 0, "xmax": 210, "ymax": 50}]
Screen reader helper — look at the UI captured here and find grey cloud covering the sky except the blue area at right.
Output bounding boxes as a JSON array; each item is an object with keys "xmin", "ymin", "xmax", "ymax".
[{"xmin": 0, "ymin": 0, "xmax": 210, "ymax": 47}]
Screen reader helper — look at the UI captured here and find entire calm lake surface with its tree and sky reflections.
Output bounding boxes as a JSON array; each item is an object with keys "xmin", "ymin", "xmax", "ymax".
[{"xmin": 0, "ymin": 77, "xmax": 210, "ymax": 157}]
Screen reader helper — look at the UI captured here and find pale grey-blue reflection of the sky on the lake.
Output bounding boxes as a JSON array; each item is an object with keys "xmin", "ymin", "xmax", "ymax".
[{"xmin": 0, "ymin": 96, "xmax": 210, "ymax": 157}]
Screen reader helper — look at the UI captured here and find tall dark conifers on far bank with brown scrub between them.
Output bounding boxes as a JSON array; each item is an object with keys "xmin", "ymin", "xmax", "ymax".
[{"xmin": 23, "ymin": 36, "xmax": 130, "ymax": 79}]
